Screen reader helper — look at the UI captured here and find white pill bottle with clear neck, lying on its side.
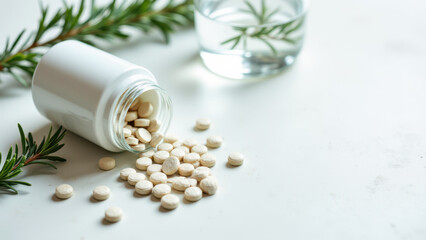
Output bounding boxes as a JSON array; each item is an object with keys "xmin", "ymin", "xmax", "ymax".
[{"xmin": 32, "ymin": 40, "xmax": 172, "ymax": 152}]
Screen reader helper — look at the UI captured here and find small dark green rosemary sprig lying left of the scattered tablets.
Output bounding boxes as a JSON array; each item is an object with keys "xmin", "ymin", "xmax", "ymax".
[{"xmin": 0, "ymin": 124, "xmax": 66, "ymax": 194}]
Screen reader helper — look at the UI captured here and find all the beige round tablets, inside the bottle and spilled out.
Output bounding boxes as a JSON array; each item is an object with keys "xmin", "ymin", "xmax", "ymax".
[{"xmin": 55, "ymin": 99, "xmax": 244, "ymax": 222}]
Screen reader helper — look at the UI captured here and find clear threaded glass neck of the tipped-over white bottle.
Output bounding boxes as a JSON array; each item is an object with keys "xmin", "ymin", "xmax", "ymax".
[{"xmin": 110, "ymin": 79, "xmax": 172, "ymax": 153}]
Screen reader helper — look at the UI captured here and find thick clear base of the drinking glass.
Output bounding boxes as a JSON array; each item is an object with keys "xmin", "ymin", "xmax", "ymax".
[{"xmin": 200, "ymin": 50, "xmax": 296, "ymax": 79}]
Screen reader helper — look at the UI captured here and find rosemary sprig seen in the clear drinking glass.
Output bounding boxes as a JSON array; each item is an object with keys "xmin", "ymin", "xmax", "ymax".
[{"xmin": 220, "ymin": 0, "xmax": 304, "ymax": 55}]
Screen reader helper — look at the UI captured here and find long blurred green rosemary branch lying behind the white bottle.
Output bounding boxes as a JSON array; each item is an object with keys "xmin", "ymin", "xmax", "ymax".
[{"xmin": 0, "ymin": 0, "xmax": 193, "ymax": 86}]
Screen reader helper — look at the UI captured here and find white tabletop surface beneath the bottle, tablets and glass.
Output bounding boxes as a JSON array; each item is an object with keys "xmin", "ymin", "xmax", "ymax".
[{"xmin": 0, "ymin": 0, "xmax": 426, "ymax": 240}]
